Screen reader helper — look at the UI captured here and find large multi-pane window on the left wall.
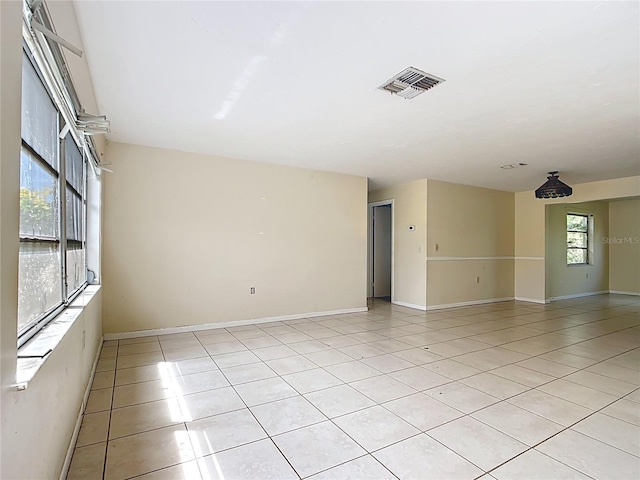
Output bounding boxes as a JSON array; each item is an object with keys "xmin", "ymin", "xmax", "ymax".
[{"xmin": 18, "ymin": 51, "xmax": 87, "ymax": 344}]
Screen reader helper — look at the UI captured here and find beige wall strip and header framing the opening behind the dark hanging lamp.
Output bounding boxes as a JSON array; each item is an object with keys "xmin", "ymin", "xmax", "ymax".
[{"xmin": 515, "ymin": 176, "xmax": 640, "ymax": 302}]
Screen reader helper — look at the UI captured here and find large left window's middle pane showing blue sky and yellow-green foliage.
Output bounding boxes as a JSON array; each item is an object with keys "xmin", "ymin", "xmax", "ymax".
[{"xmin": 20, "ymin": 150, "xmax": 58, "ymax": 238}]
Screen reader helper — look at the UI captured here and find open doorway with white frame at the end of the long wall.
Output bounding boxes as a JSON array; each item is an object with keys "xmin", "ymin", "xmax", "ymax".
[{"xmin": 367, "ymin": 200, "xmax": 393, "ymax": 302}]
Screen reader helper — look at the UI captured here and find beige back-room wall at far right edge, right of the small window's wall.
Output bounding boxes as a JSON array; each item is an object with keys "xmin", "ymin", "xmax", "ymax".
[{"xmin": 607, "ymin": 199, "xmax": 640, "ymax": 295}]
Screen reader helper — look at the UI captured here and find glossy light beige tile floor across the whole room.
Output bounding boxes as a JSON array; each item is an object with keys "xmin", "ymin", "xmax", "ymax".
[{"xmin": 68, "ymin": 295, "xmax": 640, "ymax": 480}]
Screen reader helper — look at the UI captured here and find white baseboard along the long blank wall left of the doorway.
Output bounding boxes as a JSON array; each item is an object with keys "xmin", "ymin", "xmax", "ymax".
[{"xmin": 104, "ymin": 307, "xmax": 369, "ymax": 340}]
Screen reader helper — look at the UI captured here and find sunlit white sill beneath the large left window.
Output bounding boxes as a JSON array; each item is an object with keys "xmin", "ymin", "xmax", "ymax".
[{"xmin": 16, "ymin": 285, "xmax": 100, "ymax": 390}]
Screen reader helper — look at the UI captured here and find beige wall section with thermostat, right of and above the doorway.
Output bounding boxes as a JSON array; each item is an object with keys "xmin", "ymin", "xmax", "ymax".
[{"xmin": 369, "ymin": 180, "xmax": 427, "ymax": 309}]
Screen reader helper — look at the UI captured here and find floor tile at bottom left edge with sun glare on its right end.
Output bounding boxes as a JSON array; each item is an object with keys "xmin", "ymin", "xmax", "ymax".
[{"xmin": 105, "ymin": 425, "xmax": 195, "ymax": 480}]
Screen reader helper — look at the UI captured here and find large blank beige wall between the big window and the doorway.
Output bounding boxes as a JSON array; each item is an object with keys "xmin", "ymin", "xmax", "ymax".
[{"xmin": 103, "ymin": 143, "xmax": 367, "ymax": 333}]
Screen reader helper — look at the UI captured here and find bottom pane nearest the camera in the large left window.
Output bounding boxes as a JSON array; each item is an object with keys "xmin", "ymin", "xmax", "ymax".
[{"xmin": 18, "ymin": 242, "xmax": 62, "ymax": 332}]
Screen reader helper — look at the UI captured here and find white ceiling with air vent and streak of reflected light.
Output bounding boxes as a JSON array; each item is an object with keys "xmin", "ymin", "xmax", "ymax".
[{"xmin": 75, "ymin": 1, "xmax": 640, "ymax": 191}]
